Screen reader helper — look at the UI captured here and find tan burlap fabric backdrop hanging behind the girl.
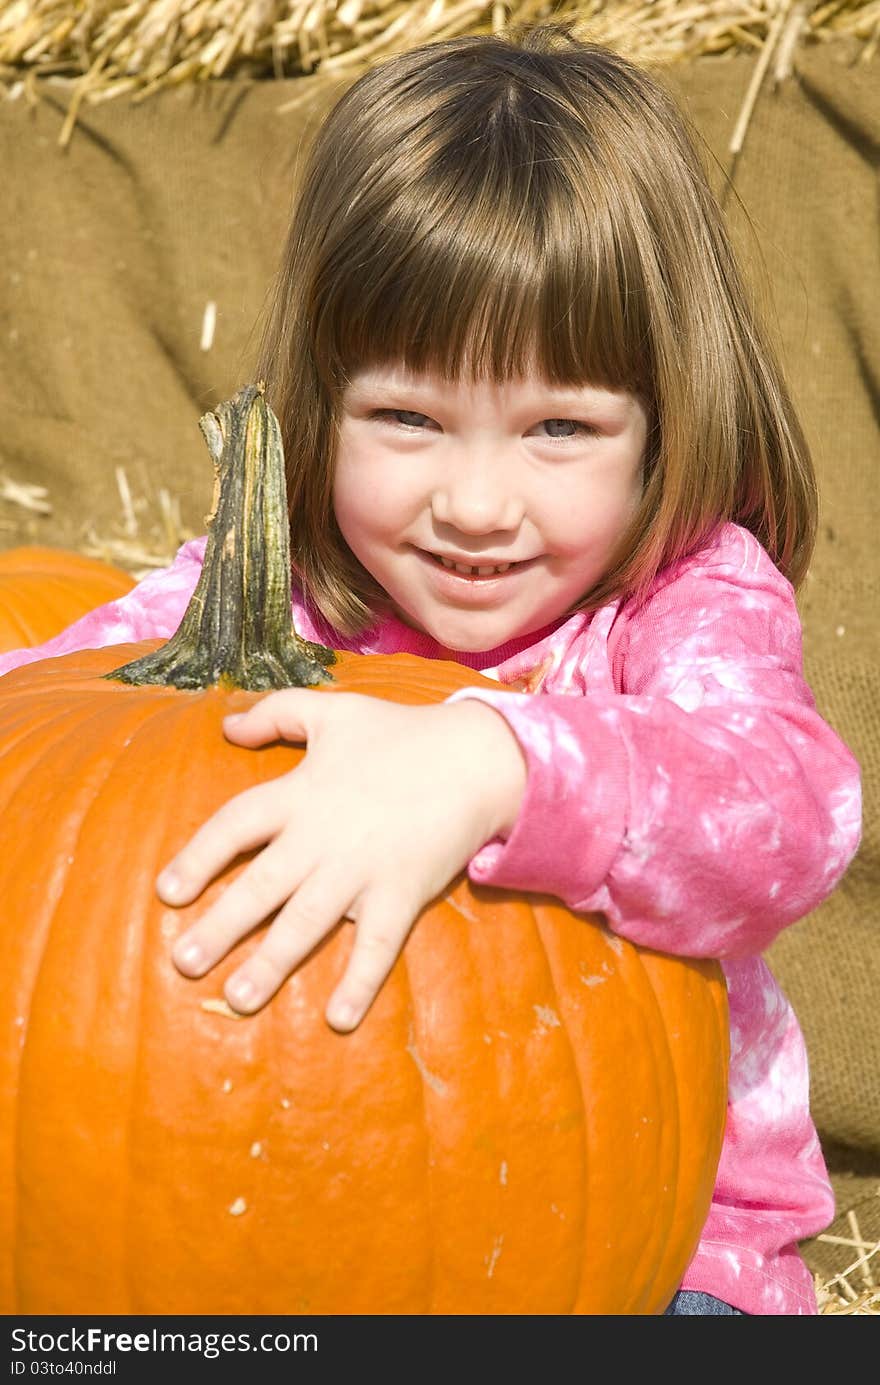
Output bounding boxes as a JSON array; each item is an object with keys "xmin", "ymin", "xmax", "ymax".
[{"xmin": 0, "ymin": 43, "xmax": 880, "ymax": 1276}]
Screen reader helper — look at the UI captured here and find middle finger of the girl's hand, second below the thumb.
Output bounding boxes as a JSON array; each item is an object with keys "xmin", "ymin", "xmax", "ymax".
[{"xmin": 172, "ymin": 835, "xmax": 311, "ymax": 976}]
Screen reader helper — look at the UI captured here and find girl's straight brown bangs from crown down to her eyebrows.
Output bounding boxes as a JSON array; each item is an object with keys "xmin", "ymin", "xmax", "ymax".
[{"xmin": 315, "ymin": 76, "xmax": 653, "ymax": 397}]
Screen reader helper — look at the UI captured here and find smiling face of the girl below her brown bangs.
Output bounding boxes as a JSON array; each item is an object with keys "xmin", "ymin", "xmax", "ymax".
[{"xmin": 334, "ymin": 367, "xmax": 647, "ymax": 652}]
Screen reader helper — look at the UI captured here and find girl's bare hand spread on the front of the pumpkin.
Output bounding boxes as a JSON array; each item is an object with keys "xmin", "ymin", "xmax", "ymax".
[{"xmin": 157, "ymin": 688, "xmax": 525, "ymax": 1030}]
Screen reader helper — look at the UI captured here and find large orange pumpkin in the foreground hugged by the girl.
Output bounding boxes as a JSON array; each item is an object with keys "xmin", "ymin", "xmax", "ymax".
[{"xmin": 0, "ymin": 389, "xmax": 728, "ymax": 1314}]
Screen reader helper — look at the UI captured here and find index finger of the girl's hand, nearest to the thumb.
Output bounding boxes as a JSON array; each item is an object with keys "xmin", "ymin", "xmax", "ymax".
[{"xmin": 155, "ymin": 770, "xmax": 292, "ymax": 904}]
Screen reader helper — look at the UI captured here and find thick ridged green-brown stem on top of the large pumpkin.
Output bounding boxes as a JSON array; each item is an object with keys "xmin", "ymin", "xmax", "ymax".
[{"xmin": 104, "ymin": 382, "xmax": 335, "ymax": 691}]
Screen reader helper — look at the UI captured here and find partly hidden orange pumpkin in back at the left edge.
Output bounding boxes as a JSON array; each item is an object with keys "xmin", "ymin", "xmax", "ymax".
[{"xmin": 0, "ymin": 544, "xmax": 134, "ymax": 654}]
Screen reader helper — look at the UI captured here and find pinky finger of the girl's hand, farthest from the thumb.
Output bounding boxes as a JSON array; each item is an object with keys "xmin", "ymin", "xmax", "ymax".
[{"xmin": 326, "ymin": 893, "xmax": 419, "ymax": 1032}]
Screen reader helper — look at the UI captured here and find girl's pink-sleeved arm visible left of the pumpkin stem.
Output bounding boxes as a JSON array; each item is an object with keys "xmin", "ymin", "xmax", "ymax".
[{"xmin": 0, "ymin": 539, "xmax": 205, "ymax": 674}]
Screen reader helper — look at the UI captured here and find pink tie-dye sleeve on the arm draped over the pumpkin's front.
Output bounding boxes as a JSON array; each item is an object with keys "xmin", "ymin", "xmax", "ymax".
[{"xmin": 455, "ymin": 526, "xmax": 861, "ymax": 957}]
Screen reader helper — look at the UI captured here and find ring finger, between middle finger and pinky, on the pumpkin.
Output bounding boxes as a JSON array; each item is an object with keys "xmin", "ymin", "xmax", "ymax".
[{"xmin": 223, "ymin": 871, "xmax": 352, "ymax": 1014}]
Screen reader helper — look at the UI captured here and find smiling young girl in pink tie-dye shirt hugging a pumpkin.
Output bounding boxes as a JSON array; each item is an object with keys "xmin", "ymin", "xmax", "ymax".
[{"xmin": 0, "ymin": 25, "xmax": 859, "ymax": 1314}]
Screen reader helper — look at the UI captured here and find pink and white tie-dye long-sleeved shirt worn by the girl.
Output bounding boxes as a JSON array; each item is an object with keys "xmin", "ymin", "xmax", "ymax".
[{"xmin": 0, "ymin": 525, "xmax": 861, "ymax": 1314}]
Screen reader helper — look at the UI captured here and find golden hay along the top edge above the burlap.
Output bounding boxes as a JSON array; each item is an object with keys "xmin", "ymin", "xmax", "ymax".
[{"xmin": 0, "ymin": 0, "xmax": 880, "ymax": 114}]
